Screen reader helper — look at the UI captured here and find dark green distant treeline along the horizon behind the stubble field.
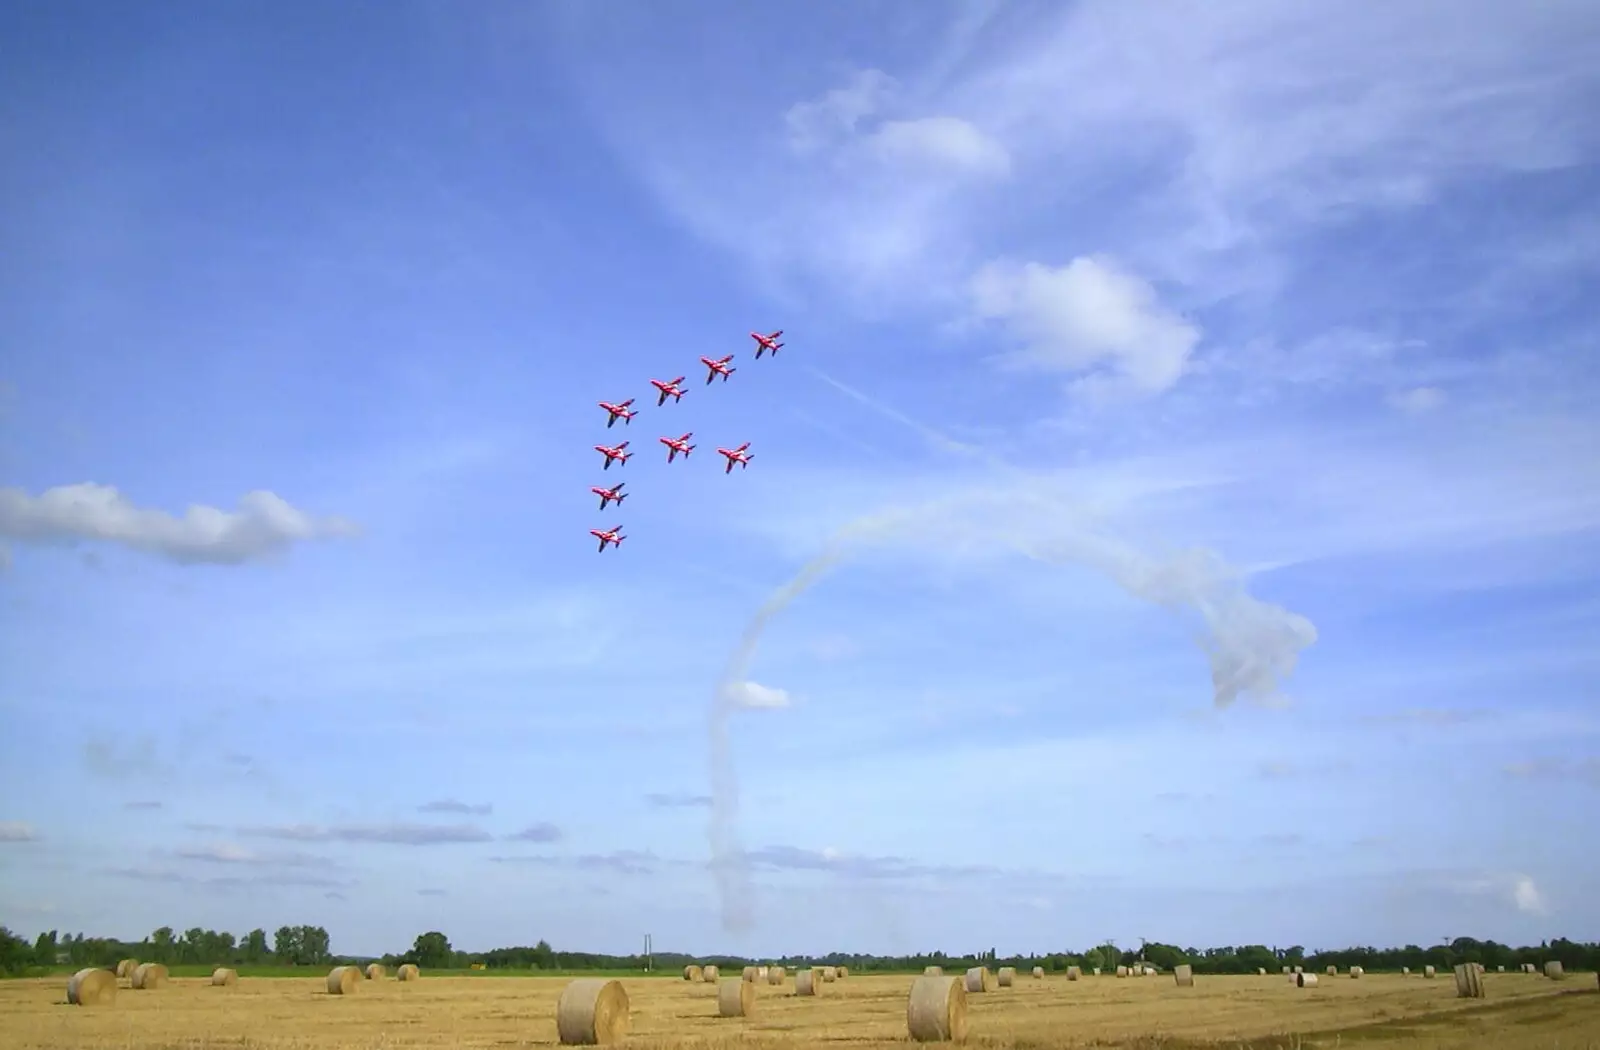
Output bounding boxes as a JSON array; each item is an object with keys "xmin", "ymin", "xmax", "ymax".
[{"xmin": 0, "ymin": 927, "xmax": 1600, "ymax": 976}]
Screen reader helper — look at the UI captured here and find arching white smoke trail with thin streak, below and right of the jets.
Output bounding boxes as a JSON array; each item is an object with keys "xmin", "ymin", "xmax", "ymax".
[{"xmin": 709, "ymin": 368, "xmax": 1317, "ymax": 932}]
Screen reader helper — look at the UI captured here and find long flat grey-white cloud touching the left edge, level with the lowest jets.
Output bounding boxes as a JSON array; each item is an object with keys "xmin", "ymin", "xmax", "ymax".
[{"xmin": 0, "ymin": 482, "xmax": 355, "ymax": 565}]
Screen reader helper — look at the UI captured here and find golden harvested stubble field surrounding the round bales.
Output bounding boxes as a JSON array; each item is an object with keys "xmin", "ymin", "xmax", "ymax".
[{"xmin": 0, "ymin": 968, "xmax": 1600, "ymax": 1050}]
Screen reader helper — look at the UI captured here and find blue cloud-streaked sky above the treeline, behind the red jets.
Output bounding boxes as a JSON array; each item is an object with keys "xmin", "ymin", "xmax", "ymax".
[{"xmin": 0, "ymin": 0, "xmax": 1600, "ymax": 954}]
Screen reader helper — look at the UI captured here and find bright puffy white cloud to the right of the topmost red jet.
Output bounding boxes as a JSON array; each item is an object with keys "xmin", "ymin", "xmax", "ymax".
[{"xmin": 973, "ymin": 258, "xmax": 1200, "ymax": 394}]
